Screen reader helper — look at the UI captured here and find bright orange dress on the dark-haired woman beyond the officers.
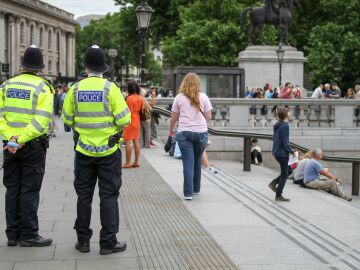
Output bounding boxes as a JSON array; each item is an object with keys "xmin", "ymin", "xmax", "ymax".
[{"xmin": 124, "ymin": 94, "xmax": 142, "ymax": 141}]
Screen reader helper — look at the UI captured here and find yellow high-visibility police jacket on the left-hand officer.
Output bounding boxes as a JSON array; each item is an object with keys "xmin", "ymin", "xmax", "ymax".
[{"xmin": 0, "ymin": 73, "xmax": 55, "ymax": 144}]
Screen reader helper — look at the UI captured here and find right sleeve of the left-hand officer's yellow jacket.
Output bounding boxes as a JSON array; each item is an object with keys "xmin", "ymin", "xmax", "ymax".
[{"xmin": 15, "ymin": 85, "xmax": 54, "ymax": 144}]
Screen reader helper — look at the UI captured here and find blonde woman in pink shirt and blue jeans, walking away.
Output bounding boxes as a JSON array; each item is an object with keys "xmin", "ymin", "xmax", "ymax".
[{"xmin": 170, "ymin": 73, "xmax": 212, "ymax": 200}]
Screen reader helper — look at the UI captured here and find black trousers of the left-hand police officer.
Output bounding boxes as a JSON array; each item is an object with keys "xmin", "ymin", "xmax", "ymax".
[{"xmin": 3, "ymin": 139, "xmax": 46, "ymax": 240}]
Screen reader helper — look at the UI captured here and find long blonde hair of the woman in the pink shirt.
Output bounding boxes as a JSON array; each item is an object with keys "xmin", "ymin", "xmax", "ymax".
[{"xmin": 179, "ymin": 73, "xmax": 200, "ymax": 111}]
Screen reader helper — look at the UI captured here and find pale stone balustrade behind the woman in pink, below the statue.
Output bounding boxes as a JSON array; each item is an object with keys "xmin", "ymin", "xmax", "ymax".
[{"xmin": 158, "ymin": 99, "xmax": 360, "ymax": 128}]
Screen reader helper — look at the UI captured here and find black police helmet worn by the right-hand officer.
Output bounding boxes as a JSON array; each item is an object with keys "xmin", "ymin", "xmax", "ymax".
[{"xmin": 83, "ymin": 45, "xmax": 109, "ymax": 72}]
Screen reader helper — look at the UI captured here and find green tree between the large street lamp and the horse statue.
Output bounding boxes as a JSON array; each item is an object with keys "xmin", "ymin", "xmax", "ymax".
[{"xmin": 163, "ymin": 0, "xmax": 275, "ymax": 66}]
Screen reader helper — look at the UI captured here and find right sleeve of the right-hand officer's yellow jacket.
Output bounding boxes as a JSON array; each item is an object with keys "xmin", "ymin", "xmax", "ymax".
[{"xmin": 109, "ymin": 83, "xmax": 131, "ymax": 127}]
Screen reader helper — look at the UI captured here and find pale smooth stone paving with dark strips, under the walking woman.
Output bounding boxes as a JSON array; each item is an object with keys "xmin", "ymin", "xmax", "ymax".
[{"xmin": 142, "ymin": 148, "xmax": 360, "ymax": 270}]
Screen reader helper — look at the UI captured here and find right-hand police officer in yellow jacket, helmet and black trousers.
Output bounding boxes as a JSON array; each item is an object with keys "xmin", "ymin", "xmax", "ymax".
[{"xmin": 62, "ymin": 45, "xmax": 131, "ymax": 255}]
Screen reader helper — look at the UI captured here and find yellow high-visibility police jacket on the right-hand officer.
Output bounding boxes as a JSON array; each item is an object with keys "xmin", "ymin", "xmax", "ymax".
[{"xmin": 62, "ymin": 77, "xmax": 131, "ymax": 157}]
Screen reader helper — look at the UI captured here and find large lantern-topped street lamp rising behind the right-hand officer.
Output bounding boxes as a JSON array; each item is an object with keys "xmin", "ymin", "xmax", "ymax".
[{"xmin": 135, "ymin": 1, "xmax": 154, "ymax": 83}]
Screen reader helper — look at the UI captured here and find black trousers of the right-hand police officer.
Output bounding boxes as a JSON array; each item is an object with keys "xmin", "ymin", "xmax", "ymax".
[{"xmin": 74, "ymin": 150, "xmax": 122, "ymax": 249}]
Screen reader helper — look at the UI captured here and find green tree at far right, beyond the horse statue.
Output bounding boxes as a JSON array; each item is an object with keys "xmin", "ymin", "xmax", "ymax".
[{"xmin": 290, "ymin": 0, "xmax": 360, "ymax": 86}]
